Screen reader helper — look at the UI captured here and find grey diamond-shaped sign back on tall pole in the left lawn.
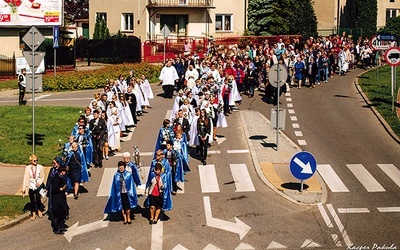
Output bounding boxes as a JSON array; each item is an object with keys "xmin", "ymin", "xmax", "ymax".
[{"xmin": 22, "ymin": 26, "xmax": 44, "ymax": 154}]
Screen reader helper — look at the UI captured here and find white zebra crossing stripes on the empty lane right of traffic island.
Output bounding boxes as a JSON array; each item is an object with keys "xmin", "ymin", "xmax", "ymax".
[{"xmin": 317, "ymin": 164, "xmax": 400, "ymax": 193}]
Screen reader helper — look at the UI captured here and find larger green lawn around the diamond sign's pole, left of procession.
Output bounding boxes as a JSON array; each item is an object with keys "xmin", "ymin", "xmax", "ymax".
[{"xmin": 0, "ymin": 106, "xmax": 81, "ymax": 166}]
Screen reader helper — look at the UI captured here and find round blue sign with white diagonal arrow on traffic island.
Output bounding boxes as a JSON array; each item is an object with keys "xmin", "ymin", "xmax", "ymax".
[{"xmin": 289, "ymin": 151, "xmax": 317, "ymax": 181}]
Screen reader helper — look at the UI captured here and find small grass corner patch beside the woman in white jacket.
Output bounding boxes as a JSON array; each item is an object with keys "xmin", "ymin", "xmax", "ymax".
[{"xmin": 0, "ymin": 195, "xmax": 29, "ymax": 219}]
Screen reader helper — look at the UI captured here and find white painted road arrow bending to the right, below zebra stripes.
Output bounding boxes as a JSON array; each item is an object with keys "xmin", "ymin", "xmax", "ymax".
[{"xmin": 203, "ymin": 196, "xmax": 251, "ymax": 239}]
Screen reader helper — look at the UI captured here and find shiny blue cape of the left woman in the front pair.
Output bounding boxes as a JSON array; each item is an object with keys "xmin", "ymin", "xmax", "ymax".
[{"xmin": 104, "ymin": 170, "xmax": 138, "ymax": 214}]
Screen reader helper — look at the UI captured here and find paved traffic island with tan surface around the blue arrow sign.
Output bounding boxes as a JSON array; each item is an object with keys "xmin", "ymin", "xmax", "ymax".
[{"xmin": 239, "ymin": 110, "xmax": 327, "ymax": 205}]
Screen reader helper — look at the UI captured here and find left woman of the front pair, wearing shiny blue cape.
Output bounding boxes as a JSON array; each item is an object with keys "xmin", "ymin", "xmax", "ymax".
[{"xmin": 104, "ymin": 161, "xmax": 138, "ymax": 224}]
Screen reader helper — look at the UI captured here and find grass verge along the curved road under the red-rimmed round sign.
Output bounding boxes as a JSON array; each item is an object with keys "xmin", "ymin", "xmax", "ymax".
[{"xmin": 359, "ymin": 66, "xmax": 400, "ymax": 137}]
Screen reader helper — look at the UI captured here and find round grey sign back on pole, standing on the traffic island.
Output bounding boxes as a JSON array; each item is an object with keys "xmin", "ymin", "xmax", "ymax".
[{"xmin": 268, "ymin": 63, "xmax": 287, "ymax": 151}]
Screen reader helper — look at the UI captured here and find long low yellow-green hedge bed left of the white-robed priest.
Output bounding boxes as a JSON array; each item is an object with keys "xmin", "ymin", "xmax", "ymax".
[{"xmin": 43, "ymin": 63, "xmax": 161, "ymax": 91}]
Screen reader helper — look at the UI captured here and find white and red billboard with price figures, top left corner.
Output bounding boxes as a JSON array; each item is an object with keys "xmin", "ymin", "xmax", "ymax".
[{"xmin": 0, "ymin": 0, "xmax": 63, "ymax": 26}]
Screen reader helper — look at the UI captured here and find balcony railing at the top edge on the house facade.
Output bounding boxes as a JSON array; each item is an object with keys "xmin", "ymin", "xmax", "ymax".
[{"xmin": 147, "ymin": 0, "xmax": 215, "ymax": 8}]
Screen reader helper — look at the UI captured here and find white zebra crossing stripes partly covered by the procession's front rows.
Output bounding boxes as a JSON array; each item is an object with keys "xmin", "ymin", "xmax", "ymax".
[{"xmin": 97, "ymin": 164, "xmax": 256, "ymax": 197}]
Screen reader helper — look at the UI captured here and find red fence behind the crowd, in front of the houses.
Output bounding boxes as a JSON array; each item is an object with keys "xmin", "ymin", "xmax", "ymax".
[{"xmin": 142, "ymin": 35, "xmax": 301, "ymax": 63}]
